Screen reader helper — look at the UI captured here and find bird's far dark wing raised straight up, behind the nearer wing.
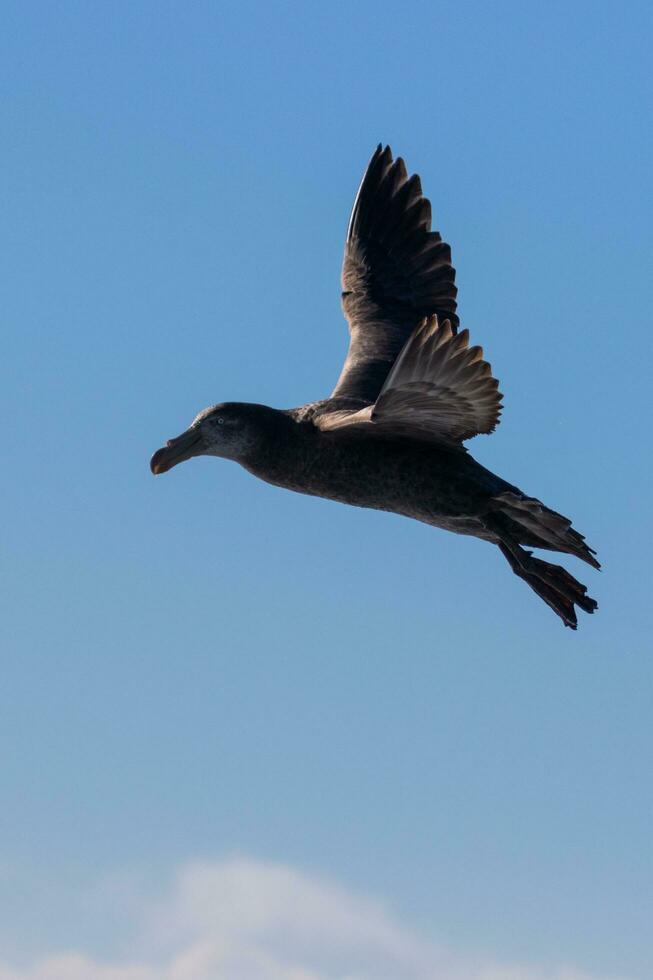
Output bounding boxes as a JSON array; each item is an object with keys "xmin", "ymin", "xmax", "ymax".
[{"xmin": 332, "ymin": 144, "xmax": 458, "ymax": 404}]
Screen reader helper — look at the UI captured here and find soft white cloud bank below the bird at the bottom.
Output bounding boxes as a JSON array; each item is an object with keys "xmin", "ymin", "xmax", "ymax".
[{"xmin": 0, "ymin": 859, "xmax": 636, "ymax": 980}]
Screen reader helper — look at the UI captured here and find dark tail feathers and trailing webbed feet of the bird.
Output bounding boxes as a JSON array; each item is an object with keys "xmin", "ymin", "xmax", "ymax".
[{"xmin": 488, "ymin": 493, "xmax": 601, "ymax": 629}]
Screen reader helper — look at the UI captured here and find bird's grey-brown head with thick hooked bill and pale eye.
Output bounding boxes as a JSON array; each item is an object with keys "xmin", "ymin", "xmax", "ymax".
[{"xmin": 150, "ymin": 402, "xmax": 283, "ymax": 476}]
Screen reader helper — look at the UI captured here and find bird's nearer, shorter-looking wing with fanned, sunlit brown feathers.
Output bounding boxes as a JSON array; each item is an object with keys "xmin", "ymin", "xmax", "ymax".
[{"xmin": 319, "ymin": 316, "xmax": 502, "ymax": 447}]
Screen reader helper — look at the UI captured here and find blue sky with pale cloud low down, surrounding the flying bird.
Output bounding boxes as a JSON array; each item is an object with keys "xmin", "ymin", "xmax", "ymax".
[{"xmin": 0, "ymin": 2, "xmax": 653, "ymax": 980}]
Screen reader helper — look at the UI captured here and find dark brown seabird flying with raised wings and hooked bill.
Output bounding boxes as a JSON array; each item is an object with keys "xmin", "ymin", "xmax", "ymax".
[{"xmin": 150, "ymin": 145, "xmax": 600, "ymax": 629}]
